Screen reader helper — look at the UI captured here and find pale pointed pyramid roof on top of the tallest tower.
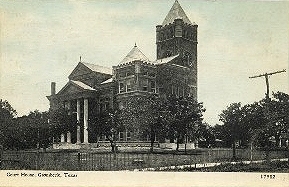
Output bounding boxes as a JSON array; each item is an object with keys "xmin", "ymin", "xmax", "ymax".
[{"xmin": 162, "ymin": 0, "xmax": 192, "ymax": 26}]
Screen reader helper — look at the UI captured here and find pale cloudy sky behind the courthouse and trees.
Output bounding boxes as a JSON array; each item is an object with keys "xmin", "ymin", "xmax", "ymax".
[{"xmin": 0, "ymin": 0, "xmax": 289, "ymax": 125}]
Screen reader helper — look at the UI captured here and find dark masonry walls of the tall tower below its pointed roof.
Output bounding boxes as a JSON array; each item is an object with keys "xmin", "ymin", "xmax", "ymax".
[{"xmin": 156, "ymin": 19, "xmax": 198, "ymax": 100}]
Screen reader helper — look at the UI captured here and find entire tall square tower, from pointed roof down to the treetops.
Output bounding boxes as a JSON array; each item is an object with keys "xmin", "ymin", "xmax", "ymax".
[{"xmin": 156, "ymin": 0, "xmax": 198, "ymax": 100}]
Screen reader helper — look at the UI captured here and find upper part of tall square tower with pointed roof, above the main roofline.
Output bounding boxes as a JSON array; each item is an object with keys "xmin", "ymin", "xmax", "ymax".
[{"xmin": 156, "ymin": 0, "xmax": 198, "ymax": 70}]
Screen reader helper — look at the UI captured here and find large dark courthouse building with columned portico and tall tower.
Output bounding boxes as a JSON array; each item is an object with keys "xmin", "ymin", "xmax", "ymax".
[{"xmin": 47, "ymin": 1, "xmax": 198, "ymax": 148}]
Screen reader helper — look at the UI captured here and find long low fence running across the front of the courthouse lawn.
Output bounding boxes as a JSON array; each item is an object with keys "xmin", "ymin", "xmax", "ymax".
[{"xmin": 1, "ymin": 149, "xmax": 288, "ymax": 171}]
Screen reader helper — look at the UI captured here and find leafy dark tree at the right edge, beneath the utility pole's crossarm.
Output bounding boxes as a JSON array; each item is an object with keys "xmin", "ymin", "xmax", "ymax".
[{"xmin": 242, "ymin": 92, "xmax": 289, "ymax": 150}]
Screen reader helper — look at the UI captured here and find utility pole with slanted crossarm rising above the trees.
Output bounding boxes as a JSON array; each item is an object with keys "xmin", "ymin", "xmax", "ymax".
[{"xmin": 249, "ymin": 69, "xmax": 286, "ymax": 161}]
